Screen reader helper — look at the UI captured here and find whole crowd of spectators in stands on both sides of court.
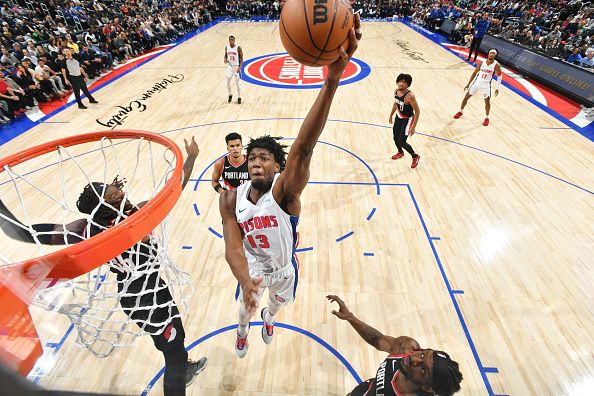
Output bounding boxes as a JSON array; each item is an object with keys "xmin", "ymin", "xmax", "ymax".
[{"xmin": 0, "ymin": 0, "xmax": 594, "ymax": 123}]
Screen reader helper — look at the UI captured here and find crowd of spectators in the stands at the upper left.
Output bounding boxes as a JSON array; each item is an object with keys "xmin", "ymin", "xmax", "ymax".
[{"xmin": 0, "ymin": 0, "xmax": 226, "ymax": 124}]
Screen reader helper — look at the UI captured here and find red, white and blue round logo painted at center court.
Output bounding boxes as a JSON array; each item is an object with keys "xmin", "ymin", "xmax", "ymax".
[{"xmin": 241, "ymin": 52, "xmax": 371, "ymax": 89}]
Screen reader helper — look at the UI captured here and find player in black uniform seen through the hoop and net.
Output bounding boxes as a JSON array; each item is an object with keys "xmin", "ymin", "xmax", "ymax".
[{"xmin": 0, "ymin": 137, "xmax": 207, "ymax": 396}]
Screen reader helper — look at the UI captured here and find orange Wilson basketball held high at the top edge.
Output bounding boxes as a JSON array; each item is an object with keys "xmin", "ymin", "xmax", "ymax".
[{"xmin": 279, "ymin": 0, "xmax": 354, "ymax": 66}]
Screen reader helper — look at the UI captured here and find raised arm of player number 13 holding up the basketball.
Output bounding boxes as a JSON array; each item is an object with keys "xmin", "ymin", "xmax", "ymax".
[{"xmin": 273, "ymin": 14, "xmax": 361, "ymax": 210}]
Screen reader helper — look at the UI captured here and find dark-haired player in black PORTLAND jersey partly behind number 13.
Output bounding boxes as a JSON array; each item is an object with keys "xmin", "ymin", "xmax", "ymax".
[{"xmin": 211, "ymin": 132, "xmax": 250, "ymax": 194}]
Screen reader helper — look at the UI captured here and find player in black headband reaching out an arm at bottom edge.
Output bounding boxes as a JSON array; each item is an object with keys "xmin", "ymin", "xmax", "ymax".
[{"xmin": 326, "ymin": 296, "xmax": 462, "ymax": 396}]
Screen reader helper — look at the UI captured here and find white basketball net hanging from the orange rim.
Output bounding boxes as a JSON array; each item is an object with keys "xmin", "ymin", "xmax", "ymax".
[{"xmin": 0, "ymin": 137, "xmax": 193, "ymax": 357}]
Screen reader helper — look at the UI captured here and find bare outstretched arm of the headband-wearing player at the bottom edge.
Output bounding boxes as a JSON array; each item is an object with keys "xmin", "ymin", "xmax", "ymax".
[{"xmin": 326, "ymin": 295, "xmax": 420, "ymax": 354}]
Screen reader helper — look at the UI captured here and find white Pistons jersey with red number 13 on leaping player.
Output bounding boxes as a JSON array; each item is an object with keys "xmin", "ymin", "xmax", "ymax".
[{"xmin": 235, "ymin": 174, "xmax": 299, "ymax": 274}]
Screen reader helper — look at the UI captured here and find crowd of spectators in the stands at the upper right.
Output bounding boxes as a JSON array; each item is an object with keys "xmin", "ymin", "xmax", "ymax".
[{"xmin": 411, "ymin": 0, "xmax": 594, "ymax": 71}]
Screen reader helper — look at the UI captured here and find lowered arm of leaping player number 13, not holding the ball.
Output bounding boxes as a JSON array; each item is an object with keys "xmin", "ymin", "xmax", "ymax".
[{"xmin": 219, "ymin": 190, "xmax": 263, "ymax": 313}]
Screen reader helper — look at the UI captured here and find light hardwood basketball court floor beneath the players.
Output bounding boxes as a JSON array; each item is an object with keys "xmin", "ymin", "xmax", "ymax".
[{"xmin": 0, "ymin": 23, "xmax": 594, "ymax": 395}]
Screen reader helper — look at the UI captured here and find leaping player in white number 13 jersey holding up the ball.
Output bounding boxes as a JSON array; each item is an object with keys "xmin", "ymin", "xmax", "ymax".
[{"xmin": 219, "ymin": 15, "xmax": 361, "ymax": 358}]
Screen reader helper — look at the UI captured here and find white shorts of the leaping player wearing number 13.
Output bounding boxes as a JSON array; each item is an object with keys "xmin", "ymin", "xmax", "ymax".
[{"xmin": 235, "ymin": 266, "xmax": 298, "ymax": 305}]
